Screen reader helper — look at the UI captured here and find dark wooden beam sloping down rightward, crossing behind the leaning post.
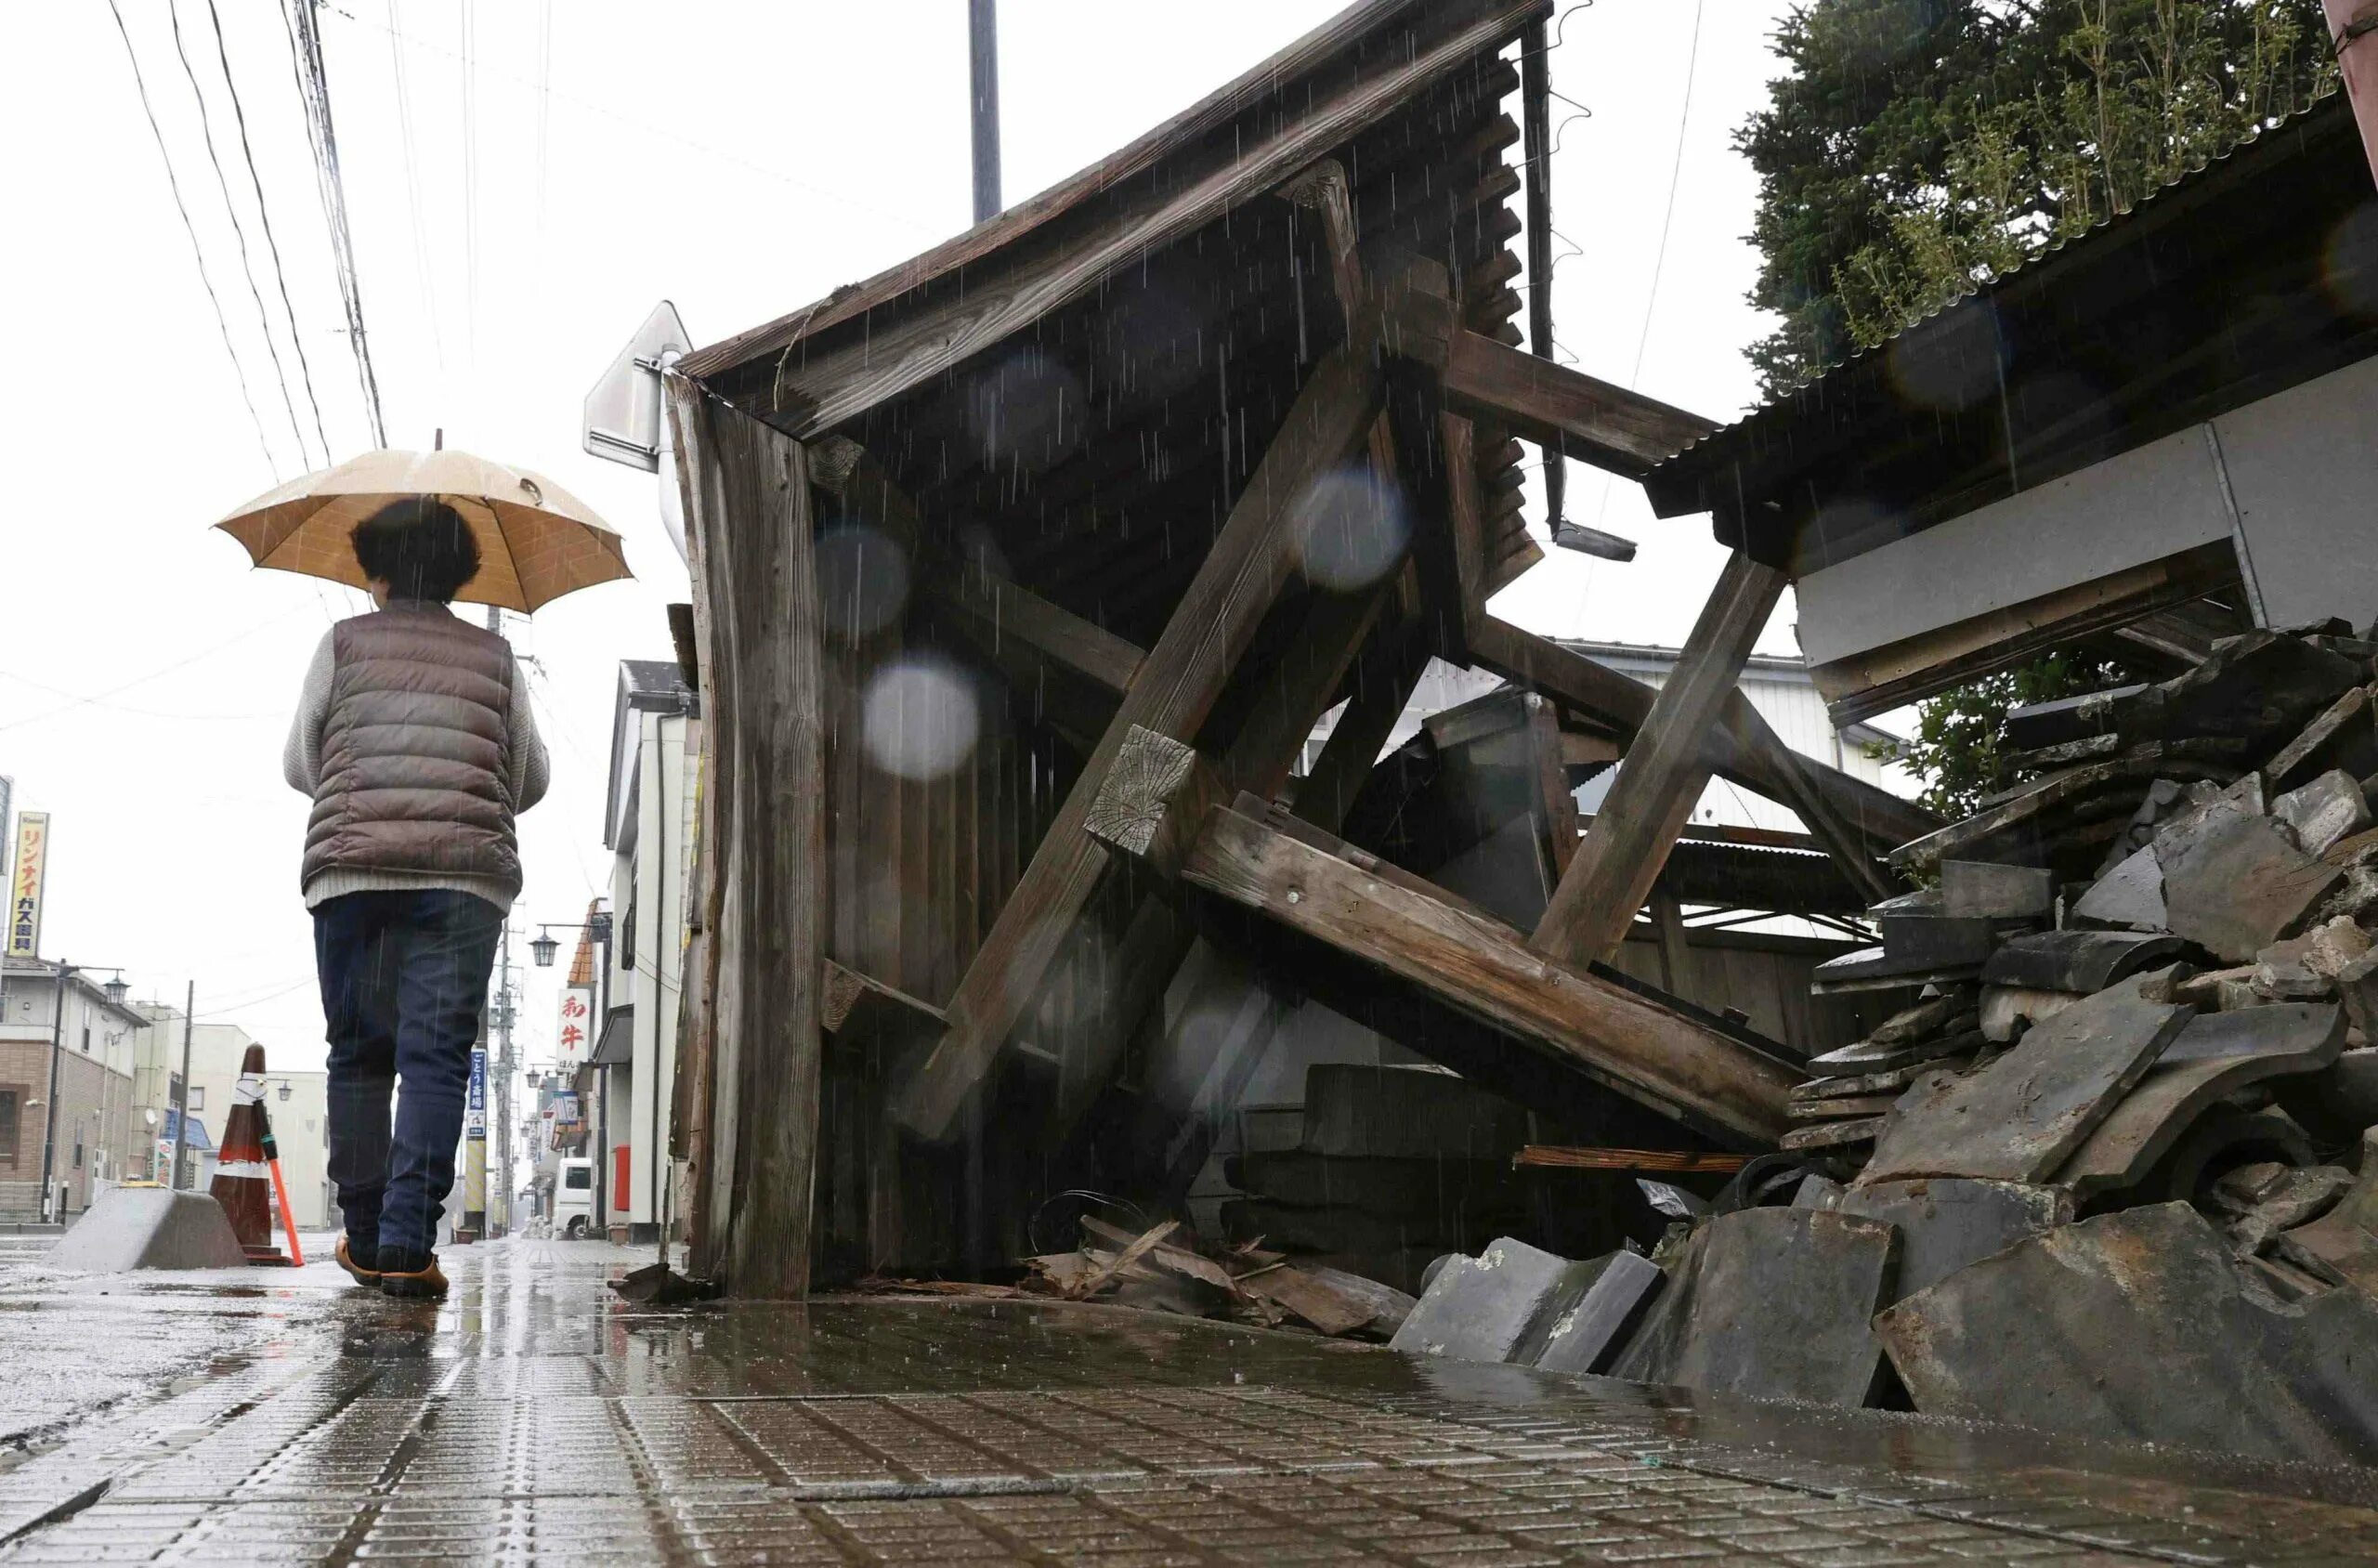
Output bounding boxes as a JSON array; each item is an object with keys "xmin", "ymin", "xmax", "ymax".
[{"xmin": 1470, "ymin": 616, "xmax": 1940, "ymax": 852}]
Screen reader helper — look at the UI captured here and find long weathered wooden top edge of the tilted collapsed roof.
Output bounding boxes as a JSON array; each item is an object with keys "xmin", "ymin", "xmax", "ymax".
[{"xmin": 678, "ymin": 0, "xmax": 1553, "ymax": 381}]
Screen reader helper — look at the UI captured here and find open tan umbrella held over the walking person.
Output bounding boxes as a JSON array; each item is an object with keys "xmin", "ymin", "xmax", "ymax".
[{"xmin": 216, "ymin": 452, "xmax": 633, "ymax": 614}]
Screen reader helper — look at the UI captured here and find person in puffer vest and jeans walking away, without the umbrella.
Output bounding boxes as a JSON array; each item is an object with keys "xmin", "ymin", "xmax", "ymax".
[{"xmin": 283, "ymin": 495, "xmax": 547, "ymax": 1297}]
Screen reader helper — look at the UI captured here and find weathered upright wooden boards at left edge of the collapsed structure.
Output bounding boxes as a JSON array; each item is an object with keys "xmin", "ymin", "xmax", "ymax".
[{"xmin": 668, "ymin": 381, "xmax": 825, "ymax": 1297}]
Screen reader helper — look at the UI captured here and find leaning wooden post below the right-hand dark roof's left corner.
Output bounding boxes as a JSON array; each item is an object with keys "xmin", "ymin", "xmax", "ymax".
[{"xmin": 1529, "ymin": 552, "xmax": 1784, "ymax": 963}]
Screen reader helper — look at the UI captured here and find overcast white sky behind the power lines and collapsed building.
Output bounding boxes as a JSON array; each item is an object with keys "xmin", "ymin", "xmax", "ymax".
[{"xmin": 0, "ymin": 0, "xmax": 1793, "ymax": 1068}]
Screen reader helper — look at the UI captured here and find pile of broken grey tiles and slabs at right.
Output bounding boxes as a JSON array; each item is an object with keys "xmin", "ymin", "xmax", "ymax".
[{"xmin": 1396, "ymin": 626, "xmax": 2378, "ymax": 1463}]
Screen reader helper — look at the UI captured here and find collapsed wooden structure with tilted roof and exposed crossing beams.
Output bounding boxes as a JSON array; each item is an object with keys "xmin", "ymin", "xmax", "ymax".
[{"xmin": 671, "ymin": 0, "xmax": 1931, "ymax": 1294}]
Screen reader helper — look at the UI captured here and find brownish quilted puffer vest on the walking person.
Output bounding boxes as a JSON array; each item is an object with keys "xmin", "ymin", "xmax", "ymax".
[{"xmin": 302, "ymin": 605, "xmax": 521, "ymax": 895}]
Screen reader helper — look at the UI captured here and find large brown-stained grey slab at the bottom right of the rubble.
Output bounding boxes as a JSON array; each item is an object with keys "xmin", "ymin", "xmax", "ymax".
[{"xmin": 1874, "ymin": 1204, "xmax": 2378, "ymax": 1466}]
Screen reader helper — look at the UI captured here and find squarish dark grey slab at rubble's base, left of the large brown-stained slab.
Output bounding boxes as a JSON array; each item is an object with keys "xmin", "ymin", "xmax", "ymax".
[{"xmin": 1610, "ymin": 1209, "xmax": 1898, "ymax": 1406}]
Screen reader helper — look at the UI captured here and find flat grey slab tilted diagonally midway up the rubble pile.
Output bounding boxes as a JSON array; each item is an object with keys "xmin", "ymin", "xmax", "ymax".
[{"xmin": 1860, "ymin": 975, "xmax": 2192, "ymax": 1183}]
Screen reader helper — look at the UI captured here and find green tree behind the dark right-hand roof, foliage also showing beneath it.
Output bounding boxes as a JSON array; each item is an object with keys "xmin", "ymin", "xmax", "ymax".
[{"xmin": 1736, "ymin": 0, "xmax": 2337, "ymax": 817}]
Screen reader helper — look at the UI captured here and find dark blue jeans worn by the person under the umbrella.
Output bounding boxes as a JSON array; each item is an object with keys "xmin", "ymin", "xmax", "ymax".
[{"xmin": 314, "ymin": 887, "xmax": 504, "ymax": 1271}]
